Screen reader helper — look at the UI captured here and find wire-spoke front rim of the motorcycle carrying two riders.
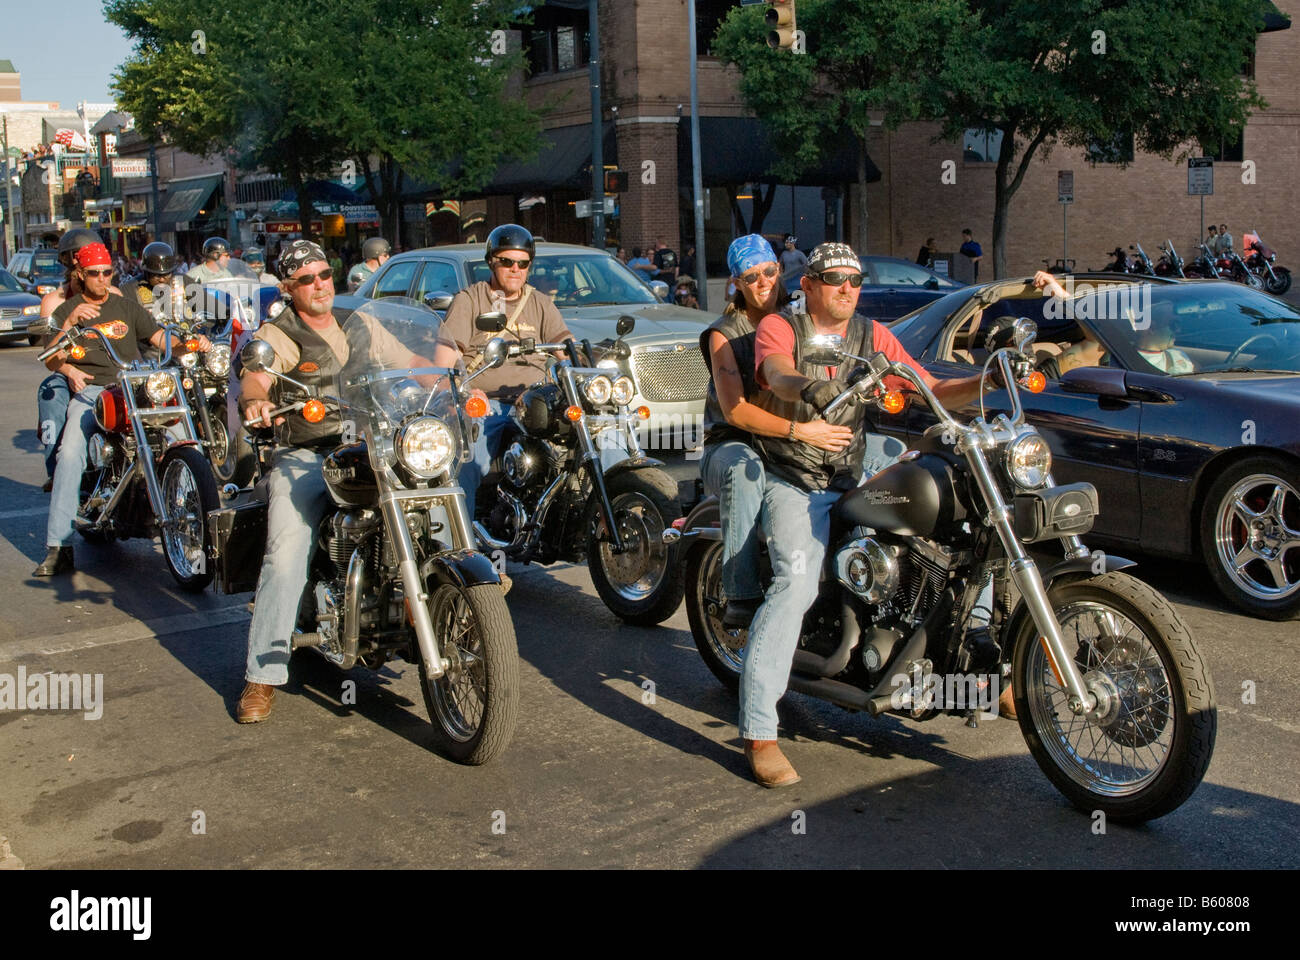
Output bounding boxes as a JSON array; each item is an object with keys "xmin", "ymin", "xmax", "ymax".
[{"xmin": 1024, "ymin": 601, "xmax": 1177, "ymax": 797}]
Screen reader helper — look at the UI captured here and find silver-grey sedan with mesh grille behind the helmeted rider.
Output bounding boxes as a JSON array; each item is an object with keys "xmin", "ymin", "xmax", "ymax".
[{"xmin": 334, "ymin": 243, "xmax": 716, "ymax": 446}]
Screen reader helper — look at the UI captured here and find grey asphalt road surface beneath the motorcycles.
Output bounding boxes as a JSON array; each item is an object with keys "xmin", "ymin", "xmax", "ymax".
[{"xmin": 0, "ymin": 347, "xmax": 1300, "ymax": 868}]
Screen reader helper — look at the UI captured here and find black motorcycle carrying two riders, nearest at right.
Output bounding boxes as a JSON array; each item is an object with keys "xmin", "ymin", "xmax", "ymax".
[{"xmin": 668, "ymin": 317, "xmax": 1217, "ymax": 822}]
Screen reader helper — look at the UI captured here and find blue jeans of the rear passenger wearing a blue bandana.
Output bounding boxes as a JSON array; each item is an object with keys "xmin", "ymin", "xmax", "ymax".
[{"xmin": 699, "ymin": 440, "xmax": 766, "ymax": 600}]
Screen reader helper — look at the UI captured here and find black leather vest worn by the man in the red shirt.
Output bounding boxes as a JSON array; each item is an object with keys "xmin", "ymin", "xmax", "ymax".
[{"xmin": 754, "ymin": 307, "xmax": 875, "ymax": 492}]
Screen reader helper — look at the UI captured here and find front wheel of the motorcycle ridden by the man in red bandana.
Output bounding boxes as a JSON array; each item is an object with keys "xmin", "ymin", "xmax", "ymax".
[{"xmin": 157, "ymin": 446, "xmax": 221, "ymax": 593}]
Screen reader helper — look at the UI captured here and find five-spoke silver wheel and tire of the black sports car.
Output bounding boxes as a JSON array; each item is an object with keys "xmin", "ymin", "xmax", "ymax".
[{"xmin": 1201, "ymin": 457, "xmax": 1300, "ymax": 620}]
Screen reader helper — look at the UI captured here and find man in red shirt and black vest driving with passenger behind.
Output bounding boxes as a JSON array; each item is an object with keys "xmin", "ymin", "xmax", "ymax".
[{"xmin": 740, "ymin": 243, "xmax": 980, "ymax": 787}]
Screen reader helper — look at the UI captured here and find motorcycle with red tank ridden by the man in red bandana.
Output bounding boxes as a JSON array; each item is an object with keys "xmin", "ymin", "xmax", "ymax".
[{"xmin": 38, "ymin": 324, "xmax": 218, "ymax": 593}]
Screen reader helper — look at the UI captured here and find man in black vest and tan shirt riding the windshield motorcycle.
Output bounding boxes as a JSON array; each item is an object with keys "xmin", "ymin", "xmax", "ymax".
[{"xmin": 235, "ymin": 239, "xmax": 433, "ymax": 723}]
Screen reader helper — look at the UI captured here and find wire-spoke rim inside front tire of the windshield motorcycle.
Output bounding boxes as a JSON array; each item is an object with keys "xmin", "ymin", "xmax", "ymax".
[{"xmin": 425, "ymin": 584, "xmax": 488, "ymax": 743}]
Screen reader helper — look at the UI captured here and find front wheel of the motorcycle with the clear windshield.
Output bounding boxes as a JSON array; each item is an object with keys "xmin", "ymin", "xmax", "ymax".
[{"xmin": 411, "ymin": 581, "xmax": 519, "ymax": 766}]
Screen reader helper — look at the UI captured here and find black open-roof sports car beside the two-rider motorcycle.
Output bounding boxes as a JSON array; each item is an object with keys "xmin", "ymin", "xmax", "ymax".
[{"xmin": 879, "ymin": 274, "xmax": 1300, "ymax": 619}]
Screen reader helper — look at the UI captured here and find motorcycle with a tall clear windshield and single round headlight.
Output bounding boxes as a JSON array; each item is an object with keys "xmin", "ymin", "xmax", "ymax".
[{"xmin": 208, "ymin": 298, "xmax": 519, "ymax": 764}]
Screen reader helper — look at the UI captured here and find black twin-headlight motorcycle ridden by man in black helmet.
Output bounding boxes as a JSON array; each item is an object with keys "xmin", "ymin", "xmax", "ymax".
[{"xmin": 475, "ymin": 313, "xmax": 685, "ymax": 626}]
